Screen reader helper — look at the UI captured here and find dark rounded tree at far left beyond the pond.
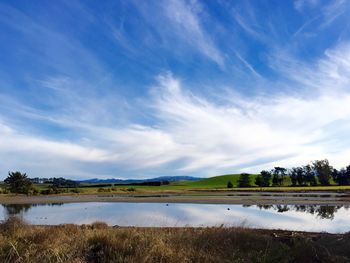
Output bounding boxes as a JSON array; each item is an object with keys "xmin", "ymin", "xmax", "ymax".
[{"xmin": 4, "ymin": 171, "xmax": 32, "ymax": 194}]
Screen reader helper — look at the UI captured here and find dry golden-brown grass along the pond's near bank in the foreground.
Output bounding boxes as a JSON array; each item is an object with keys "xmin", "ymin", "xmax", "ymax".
[{"xmin": 0, "ymin": 217, "xmax": 350, "ymax": 263}]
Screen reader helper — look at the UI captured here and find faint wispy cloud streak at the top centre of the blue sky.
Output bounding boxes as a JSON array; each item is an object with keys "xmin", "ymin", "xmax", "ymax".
[{"xmin": 124, "ymin": 0, "xmax": 225, "ymax": 68}]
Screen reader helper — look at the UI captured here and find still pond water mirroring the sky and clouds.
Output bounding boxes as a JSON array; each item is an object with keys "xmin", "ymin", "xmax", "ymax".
[{"xmin": 0, "ymin": 202, "xmax": 350, "ymax": 233}]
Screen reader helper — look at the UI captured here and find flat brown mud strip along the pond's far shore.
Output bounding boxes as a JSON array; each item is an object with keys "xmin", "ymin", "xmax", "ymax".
[{"xmin": 0, "ymin": 192, "xmax": 350, "ymax": 205}]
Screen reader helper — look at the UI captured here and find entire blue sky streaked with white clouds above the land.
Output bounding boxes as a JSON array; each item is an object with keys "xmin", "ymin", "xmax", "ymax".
[{"xmin": 0, "ymin": 0, "xmax": 350, "ymax": 179}]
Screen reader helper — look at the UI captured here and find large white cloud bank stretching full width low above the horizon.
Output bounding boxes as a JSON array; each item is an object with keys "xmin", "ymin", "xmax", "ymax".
[{"xmin": 0, "ymin": 40, "xmax": 350, "ymax": 176}]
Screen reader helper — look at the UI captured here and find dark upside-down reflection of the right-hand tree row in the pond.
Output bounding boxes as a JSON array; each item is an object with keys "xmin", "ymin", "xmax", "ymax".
[{"xmin": 257, "ymin": 205, "xmax": 349, "ymax": 220}]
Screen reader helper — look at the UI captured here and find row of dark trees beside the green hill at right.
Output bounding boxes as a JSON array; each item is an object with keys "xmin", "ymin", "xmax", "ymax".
[{"xmin": 227, "ymin": 159, "xmax": 350, "ymax": 188}]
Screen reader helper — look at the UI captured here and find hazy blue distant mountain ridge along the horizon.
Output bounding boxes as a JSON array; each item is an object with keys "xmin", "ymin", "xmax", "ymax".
[{"xmin": 77, "ymin": 176, "xmax": 203, "ymax": 184}]
